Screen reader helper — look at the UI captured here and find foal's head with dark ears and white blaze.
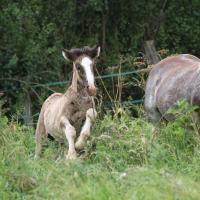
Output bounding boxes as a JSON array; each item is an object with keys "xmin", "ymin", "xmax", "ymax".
[{"xmin": 62, "ymin": 47, "xmax": 100, "ymax": 96}]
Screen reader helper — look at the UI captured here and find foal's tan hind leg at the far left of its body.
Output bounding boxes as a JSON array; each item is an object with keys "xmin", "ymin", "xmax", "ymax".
[{"xmin": 35, "ymin": 110, "xmax": 46, "ymax": 159}]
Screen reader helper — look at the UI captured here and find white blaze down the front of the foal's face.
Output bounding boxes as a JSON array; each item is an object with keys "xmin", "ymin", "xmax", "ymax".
[{"xmin": 81, "ymin": 57, "xmax": 94, "ymax": 85}]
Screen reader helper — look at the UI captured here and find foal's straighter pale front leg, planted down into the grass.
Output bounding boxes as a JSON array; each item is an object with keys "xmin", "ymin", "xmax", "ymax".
[{"xmin": 61, "ymin": 117, "xmax": 76, "ymax": 159}]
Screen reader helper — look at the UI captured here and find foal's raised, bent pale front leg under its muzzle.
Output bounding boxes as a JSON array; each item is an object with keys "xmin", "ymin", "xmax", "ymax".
[{"xmin": 75, "ymin": 108, "xmax": 97, "ymax": 150}]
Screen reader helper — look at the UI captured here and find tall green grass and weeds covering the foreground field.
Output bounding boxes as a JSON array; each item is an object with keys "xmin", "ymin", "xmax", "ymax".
[{"xmin": 0, "ymin": 104, "xmax": 200, "ymax": 200}]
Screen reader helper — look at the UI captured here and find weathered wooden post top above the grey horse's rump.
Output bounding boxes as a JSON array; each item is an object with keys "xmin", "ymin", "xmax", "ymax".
[{"xmin": 144, "ymin": 40, "xmax": 160, "ymax": 65}]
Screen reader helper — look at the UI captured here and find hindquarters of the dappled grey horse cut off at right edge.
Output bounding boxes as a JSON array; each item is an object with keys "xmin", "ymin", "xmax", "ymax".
[{"xmin": 145, "ymin": 54, "xmax": 200, "ymax": 122}]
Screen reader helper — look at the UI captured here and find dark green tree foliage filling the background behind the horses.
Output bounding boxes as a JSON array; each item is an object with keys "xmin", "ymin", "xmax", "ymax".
[{"xmin": 0, "ymin": 0, "xmax": 200, "ymax": 114}]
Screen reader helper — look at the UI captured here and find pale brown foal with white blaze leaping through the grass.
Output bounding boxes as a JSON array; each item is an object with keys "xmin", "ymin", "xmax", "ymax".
[{"xmin": 35, "ymin": 47, "xmax": 100, "ymax": 159}]
